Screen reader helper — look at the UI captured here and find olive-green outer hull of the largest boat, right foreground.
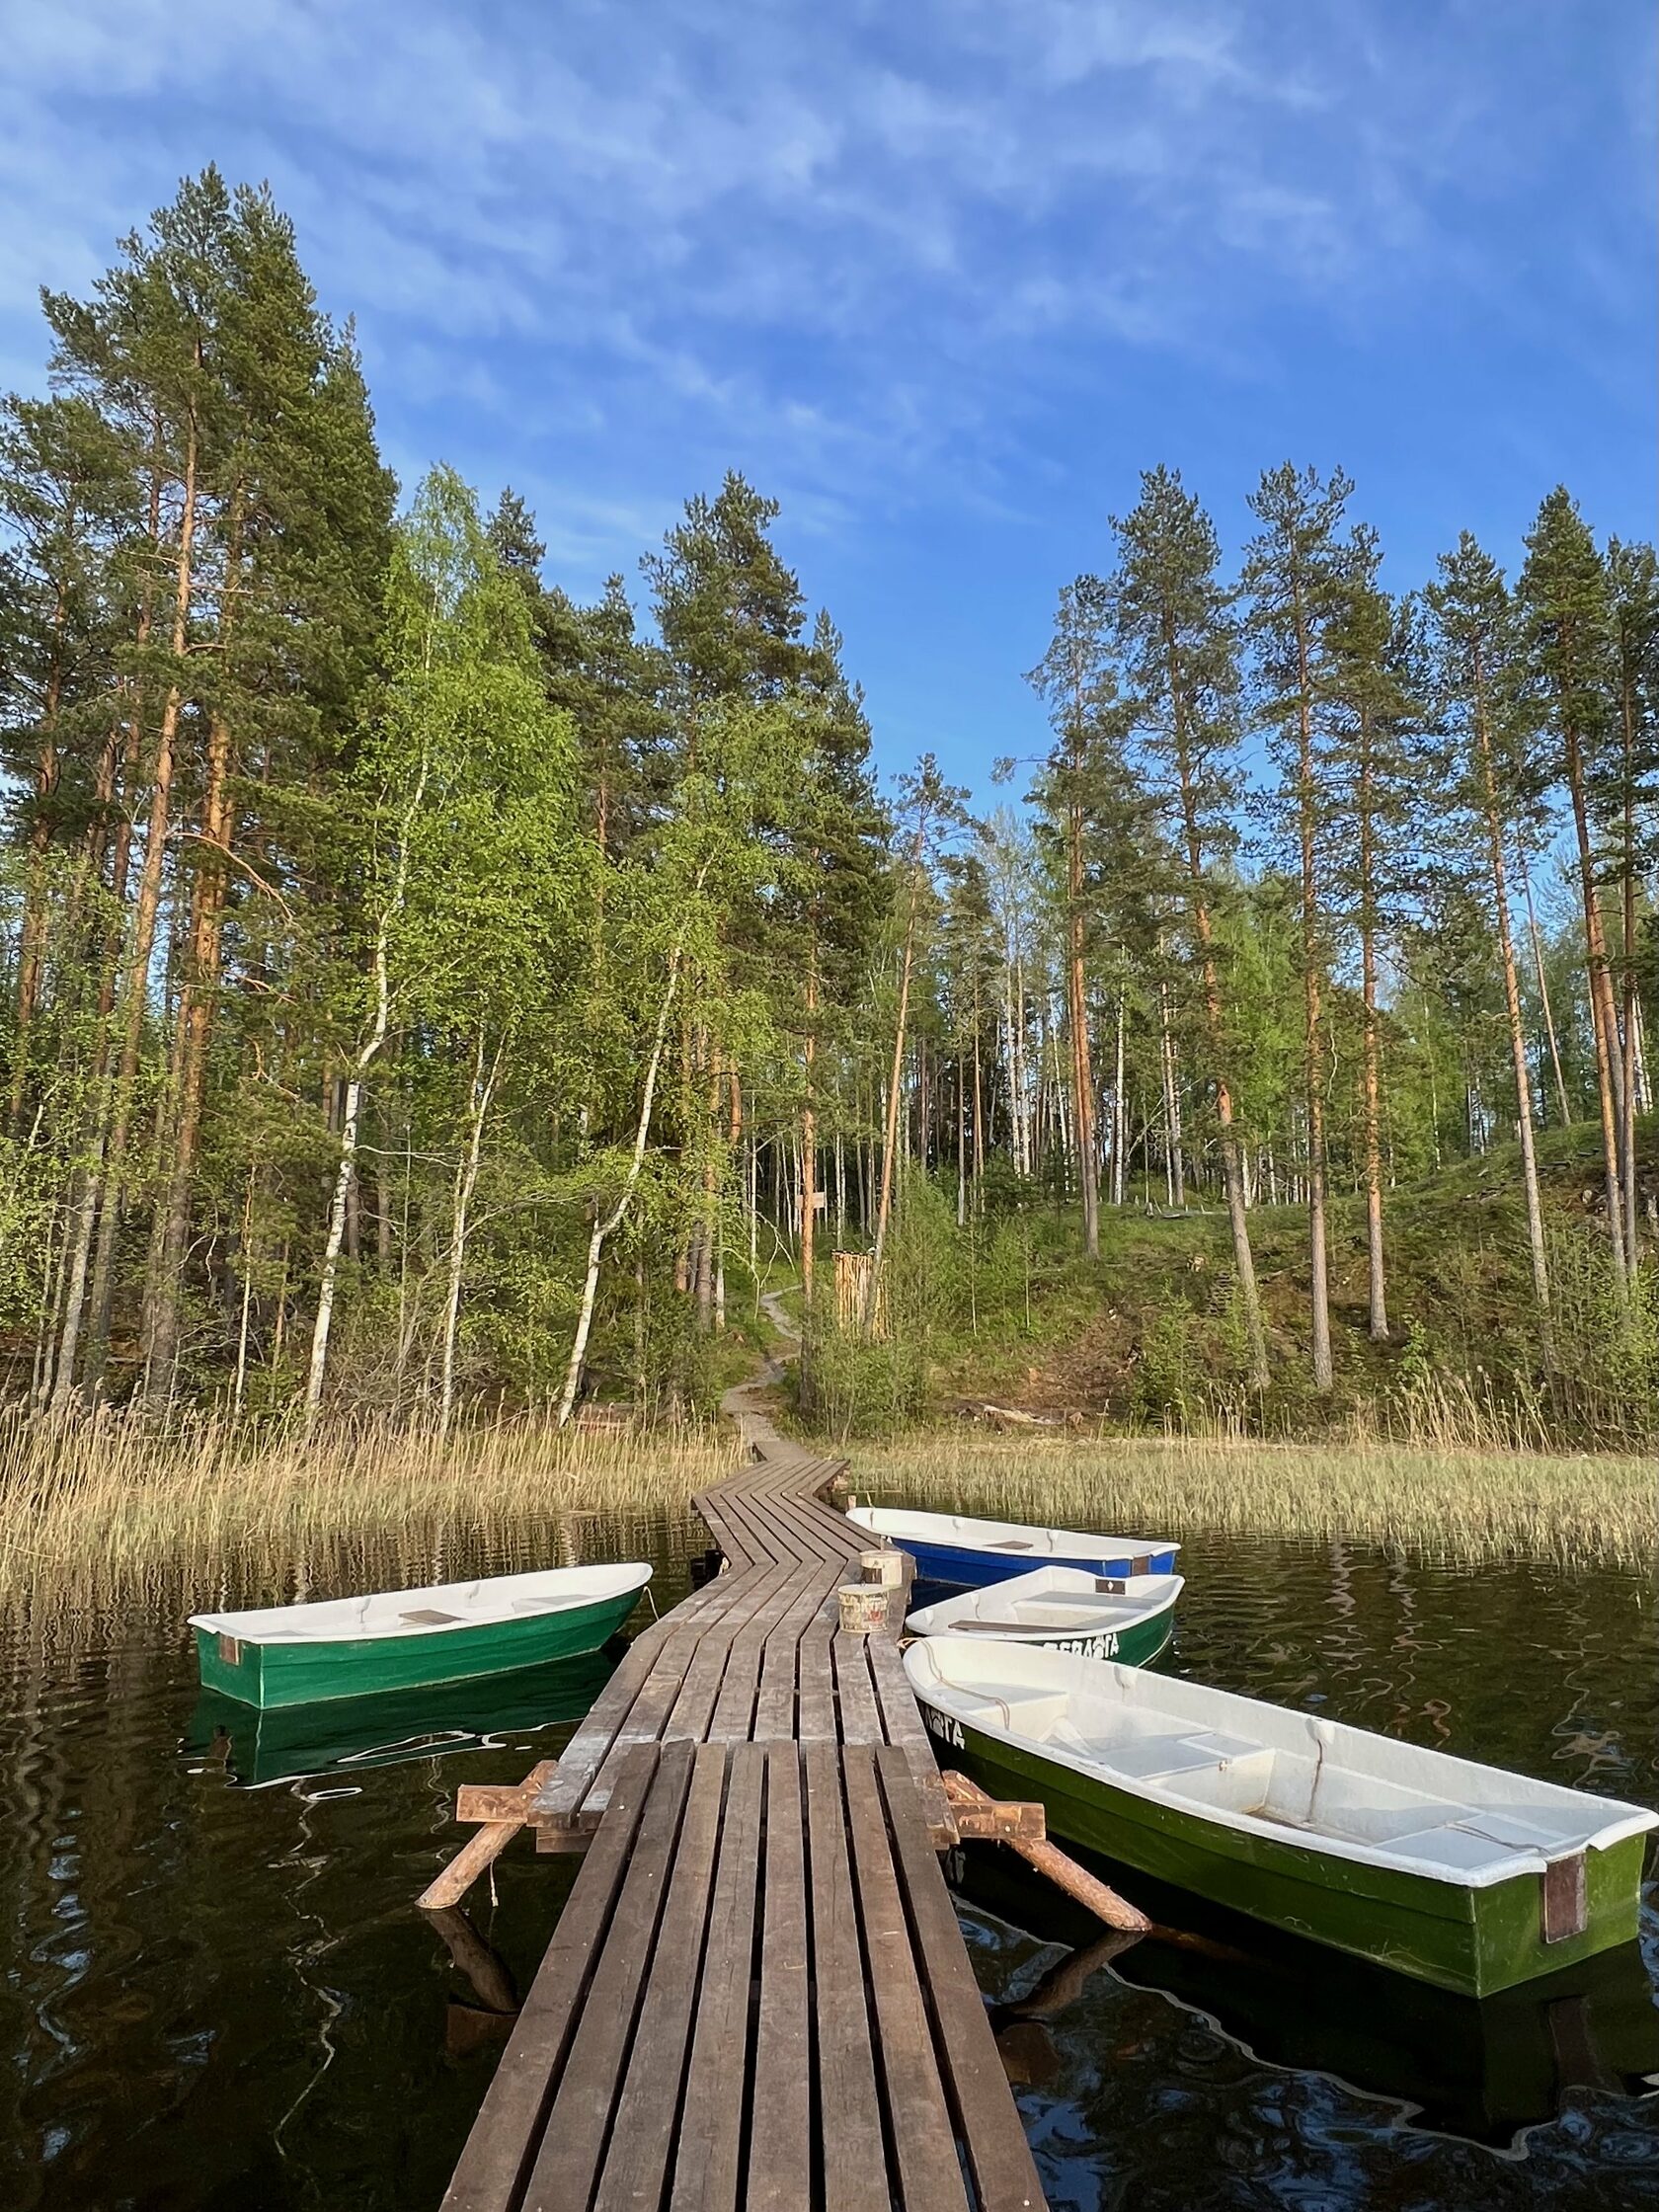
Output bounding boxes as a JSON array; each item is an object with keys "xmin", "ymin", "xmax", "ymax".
[{"xmin": 922, "ymin": 1705, "xmax": 1646, "ymax": 1998}]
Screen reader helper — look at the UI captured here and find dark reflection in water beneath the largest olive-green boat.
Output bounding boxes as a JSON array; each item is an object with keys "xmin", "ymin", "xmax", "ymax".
[{"xmin": 947, "ymin": 1847, "xmax": 1659, "ymax": 2148}]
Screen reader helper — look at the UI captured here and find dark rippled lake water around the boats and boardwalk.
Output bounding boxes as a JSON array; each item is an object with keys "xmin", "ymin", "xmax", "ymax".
[{"xmin": 0, "ymin": 1522, "xmax": 1659, "ymax": 2212}]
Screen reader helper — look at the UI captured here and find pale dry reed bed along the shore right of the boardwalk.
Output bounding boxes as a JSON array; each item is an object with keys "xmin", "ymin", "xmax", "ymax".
[{"xmin": 849, "ymin": 1434, "xmax": 1659, "ymax": 1570}]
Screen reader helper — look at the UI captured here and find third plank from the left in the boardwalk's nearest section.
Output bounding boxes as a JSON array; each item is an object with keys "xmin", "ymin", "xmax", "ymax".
[{"xmin": 595, "ymin": 1743, "xmax": 726, "ymax": 2212}]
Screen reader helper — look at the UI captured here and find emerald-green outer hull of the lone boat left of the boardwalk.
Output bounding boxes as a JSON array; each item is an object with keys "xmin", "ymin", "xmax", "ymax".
[{"xmin": 195, "ymin": 1591, "xmax": 639, "ymax": 1707}]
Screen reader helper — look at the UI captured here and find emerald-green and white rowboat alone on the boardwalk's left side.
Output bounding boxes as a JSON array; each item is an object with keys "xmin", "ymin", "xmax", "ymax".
[{"xmin": 191, "ymin": 1564, "xmax": 651, "ymax": 1705}]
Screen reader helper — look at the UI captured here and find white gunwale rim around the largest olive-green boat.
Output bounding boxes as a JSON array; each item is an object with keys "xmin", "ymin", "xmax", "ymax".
[{"xmin": 905, "ymin": 1637, "xmax": 1659, "ymax": 1889}]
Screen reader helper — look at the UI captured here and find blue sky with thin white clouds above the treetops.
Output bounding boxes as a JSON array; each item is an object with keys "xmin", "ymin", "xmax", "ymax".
[{"xmin": 0, "ymin": 0, "xmax": 1659, "ymax": 785}]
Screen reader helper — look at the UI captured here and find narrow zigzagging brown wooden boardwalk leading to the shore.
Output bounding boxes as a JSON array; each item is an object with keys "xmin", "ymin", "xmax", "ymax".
[{"xmin": 444, "ymin": 1391, "xmax": 1042, "ymax": 2212}]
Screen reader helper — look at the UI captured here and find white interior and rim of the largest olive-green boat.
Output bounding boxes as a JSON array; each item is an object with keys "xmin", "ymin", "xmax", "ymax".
[{"xmin": 905, "ymin": 1637, "xmax": 1659, "ymax": 1889}]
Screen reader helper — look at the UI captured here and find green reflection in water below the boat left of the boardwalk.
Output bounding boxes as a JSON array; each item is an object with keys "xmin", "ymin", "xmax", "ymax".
[{"xmin": 179, "ymin": 1641, "xmax": 626, "ymax": 1789}]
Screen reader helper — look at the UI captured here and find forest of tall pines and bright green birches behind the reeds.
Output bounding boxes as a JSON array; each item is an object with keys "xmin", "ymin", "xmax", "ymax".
[{"xmin": 0, "ymin": 170, "xmax": 1659, "ymax": 1440}]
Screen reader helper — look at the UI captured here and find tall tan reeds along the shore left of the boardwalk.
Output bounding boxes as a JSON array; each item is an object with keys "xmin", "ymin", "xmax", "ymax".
[{"xmin": 0, "ymin": 1416, "xmax": 732, "ymax": 1604}]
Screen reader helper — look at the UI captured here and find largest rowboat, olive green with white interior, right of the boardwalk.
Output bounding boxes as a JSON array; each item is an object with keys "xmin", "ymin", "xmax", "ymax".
[{"xmin": 905, "ymin": 1637, "xmax": 1659, "ymax": 1998}]
